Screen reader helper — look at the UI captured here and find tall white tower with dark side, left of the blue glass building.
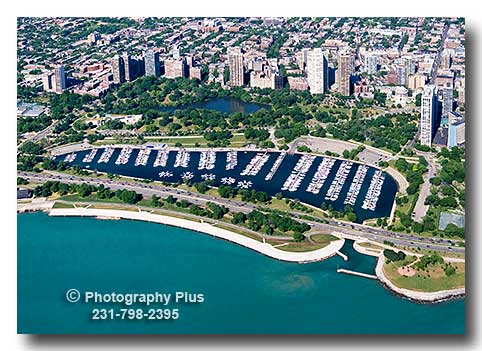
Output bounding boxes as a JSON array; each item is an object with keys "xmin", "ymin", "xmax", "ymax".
[{"xmin": 420, "ymin": 84, "xmax": 437, "ymax": 146}]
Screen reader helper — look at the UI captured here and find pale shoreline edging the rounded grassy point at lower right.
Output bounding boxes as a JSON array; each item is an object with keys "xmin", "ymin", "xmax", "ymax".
[{"xmin": 353, "ymin": 241, "xmax": 465, "ymax": 303}]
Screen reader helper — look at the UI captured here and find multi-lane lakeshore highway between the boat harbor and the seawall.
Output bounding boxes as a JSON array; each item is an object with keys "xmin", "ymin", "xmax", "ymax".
[{"xmin": 18, "ymin": 171, "xmax": 465, "ymax": 253}]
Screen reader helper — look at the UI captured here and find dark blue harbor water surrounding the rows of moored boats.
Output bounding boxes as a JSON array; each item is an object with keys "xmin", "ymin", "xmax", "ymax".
[{"xmin": 57, "ymin": 148, "xmax": 397, "ymax": 222}]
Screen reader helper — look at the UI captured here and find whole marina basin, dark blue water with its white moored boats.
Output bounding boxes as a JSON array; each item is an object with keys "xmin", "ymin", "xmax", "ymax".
[{"xmin": 57, "ymin": 146, "xmax": 396, "ymax": 221}]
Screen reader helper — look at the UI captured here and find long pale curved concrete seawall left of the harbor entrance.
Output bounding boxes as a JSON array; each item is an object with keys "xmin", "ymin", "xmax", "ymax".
[{"xmin": 49, "ymin": 208, "xmax": 345, "ymax": 263}]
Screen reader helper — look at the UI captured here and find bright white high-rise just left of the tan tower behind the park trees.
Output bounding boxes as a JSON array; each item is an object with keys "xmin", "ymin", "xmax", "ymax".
[{"xmin": 306, "ymin": 48, "xmax": 328, "ymax": 94}]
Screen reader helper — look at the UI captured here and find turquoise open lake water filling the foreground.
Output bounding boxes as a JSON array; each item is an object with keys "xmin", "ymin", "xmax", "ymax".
[{"xmin": 17, "ymin": 213, "xmax": 465, "ymax": 334}]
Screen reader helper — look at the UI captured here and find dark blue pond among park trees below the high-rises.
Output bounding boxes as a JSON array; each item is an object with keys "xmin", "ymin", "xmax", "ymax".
[{"xmin": 159, "ymin": 97, "xmax": 271, "ymax": 114}]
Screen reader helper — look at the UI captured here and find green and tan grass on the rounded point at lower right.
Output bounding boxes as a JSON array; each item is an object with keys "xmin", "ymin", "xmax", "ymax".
[{"xmin": 383, "ymin": 256, "xmax": 465, "ymax": 292}]
